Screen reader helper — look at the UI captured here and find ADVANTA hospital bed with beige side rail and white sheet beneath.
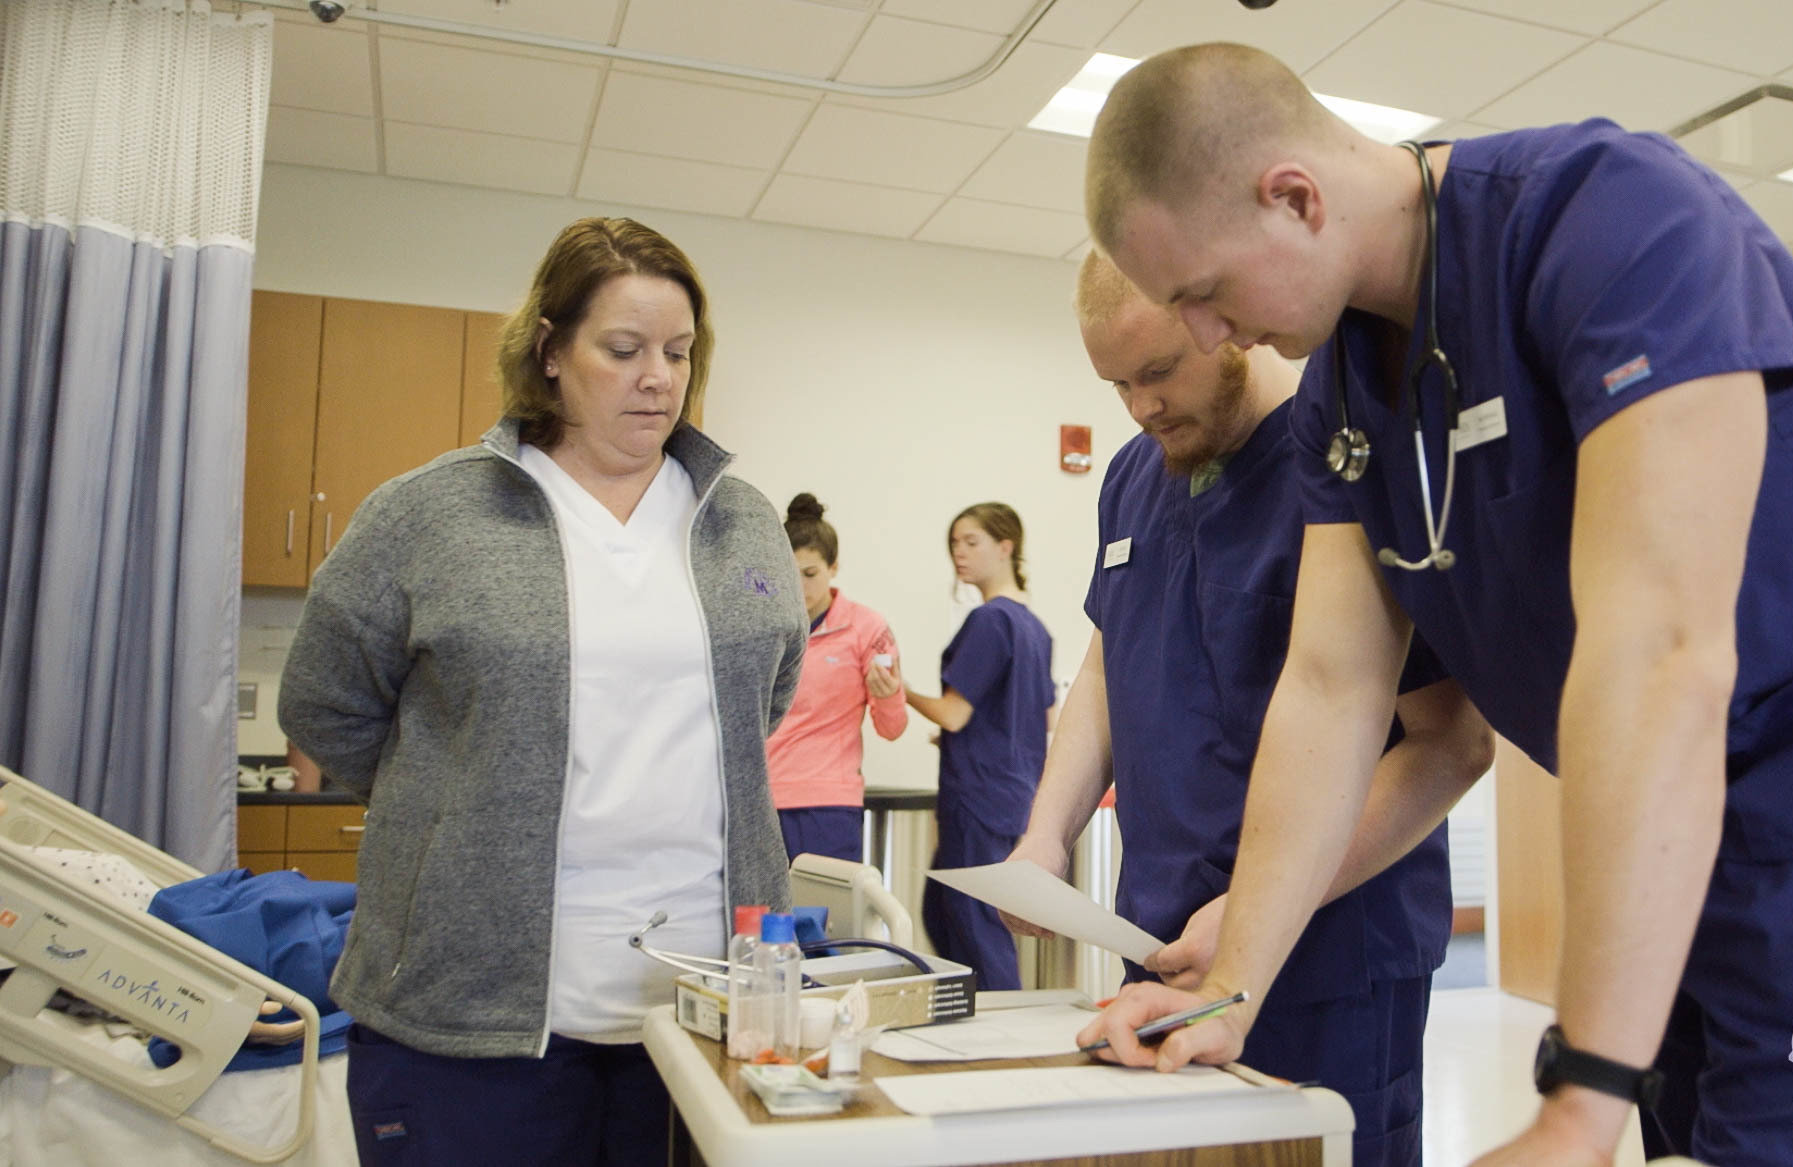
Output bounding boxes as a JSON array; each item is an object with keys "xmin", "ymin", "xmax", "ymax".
[{"xmin": 0, "ymin": 767, "xmax": 355, "ymax": 1167}]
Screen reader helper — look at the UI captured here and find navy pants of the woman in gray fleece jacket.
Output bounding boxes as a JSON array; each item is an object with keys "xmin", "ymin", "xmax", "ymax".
[{"xmin": 348, "ymin": 1024, "xmax": 672, "ymax": 1167}]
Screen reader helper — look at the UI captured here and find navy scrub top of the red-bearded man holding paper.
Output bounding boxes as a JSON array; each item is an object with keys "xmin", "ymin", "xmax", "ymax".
[{"xmin": 1085, "ymin": 412, "xmax": 1451, "ymax": 1002}]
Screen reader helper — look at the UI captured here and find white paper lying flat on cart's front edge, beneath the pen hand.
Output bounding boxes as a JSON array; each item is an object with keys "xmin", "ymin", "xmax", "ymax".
[{"xmin": 879, "ymin": 1065, "xmax": 1259, "ymax": 1115}]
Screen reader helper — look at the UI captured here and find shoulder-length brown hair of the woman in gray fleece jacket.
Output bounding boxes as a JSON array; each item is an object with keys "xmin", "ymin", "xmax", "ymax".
[{"xmin": 498, "ymin": 219, "xmax": 715, "ymax": 450}]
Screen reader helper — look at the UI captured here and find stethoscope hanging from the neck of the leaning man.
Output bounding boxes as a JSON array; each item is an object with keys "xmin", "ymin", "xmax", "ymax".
[{"xmin": 1327, "ymin": 142, "xmax": 1460, "ymax": 572}]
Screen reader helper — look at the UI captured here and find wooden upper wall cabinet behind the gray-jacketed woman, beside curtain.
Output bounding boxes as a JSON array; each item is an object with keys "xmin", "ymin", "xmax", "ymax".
[{"xmin": 242, "ymin": 292, "xmax": 502, "ymax": 588}]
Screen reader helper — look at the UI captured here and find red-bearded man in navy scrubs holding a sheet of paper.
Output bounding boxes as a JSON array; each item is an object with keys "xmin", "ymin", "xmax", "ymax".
[{"xmin": 1011, "ymin": 253, "xmax": 1492, "ymax": 1167}]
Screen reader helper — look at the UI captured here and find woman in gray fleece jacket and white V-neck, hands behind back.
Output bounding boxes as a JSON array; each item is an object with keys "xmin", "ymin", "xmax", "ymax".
[{"xmin": 280, "ymin": 219, "xmax": 807, "ymax": 1165}]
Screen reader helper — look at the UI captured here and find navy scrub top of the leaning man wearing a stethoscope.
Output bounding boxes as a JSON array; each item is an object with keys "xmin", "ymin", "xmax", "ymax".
[{"xmin": 1291, "ymin": 120, "xmax": 1793, "ymax": 859}]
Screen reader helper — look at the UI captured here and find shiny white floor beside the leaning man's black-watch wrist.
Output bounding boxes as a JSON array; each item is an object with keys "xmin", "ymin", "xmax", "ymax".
[{"xmin": 1425, "ymin": 988, "xmax": 1644, "ymax": 1167}]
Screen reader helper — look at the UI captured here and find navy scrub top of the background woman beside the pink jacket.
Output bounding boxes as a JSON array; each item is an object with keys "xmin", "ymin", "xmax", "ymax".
[{"xmin": 936, "ymin": 595, "xmax": 1054, "ymax": 837}]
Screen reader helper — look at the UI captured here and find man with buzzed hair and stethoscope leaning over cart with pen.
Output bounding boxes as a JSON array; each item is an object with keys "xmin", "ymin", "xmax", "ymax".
[{"xmin": 1088, "ymin": 45, "xmax": 1793, "ymax": 1167}]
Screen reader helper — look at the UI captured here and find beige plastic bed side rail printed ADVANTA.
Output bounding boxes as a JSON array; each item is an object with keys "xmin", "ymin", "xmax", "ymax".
[{"xmin": 0, "ymin": 767, "xmax": 319, "ymax": 1163}]
